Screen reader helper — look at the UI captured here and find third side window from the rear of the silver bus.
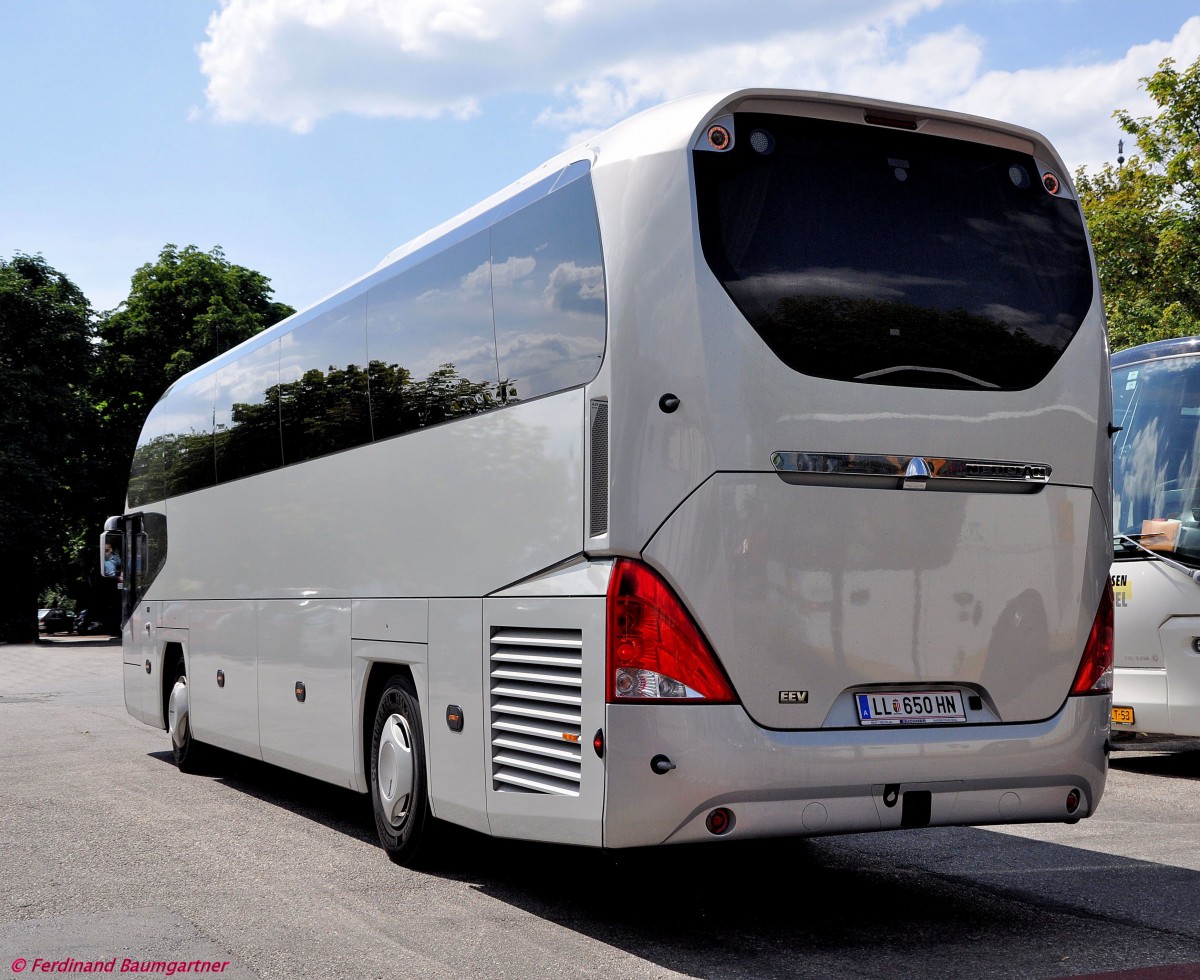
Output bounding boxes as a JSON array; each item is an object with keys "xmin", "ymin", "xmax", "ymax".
[{"xmin": 280, "ymin": 296, "xmax": 371, "ymax": 464}]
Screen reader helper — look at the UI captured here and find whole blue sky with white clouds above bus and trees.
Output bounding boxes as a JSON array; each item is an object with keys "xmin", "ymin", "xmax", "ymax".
[{"xmin": 0, "ymin": 0, "xmax": 1200, "ymax": 311}]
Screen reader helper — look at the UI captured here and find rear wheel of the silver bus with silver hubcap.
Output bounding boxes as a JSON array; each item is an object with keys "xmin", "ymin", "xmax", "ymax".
[{"xmin": 371, "ymin": 674, "xmax": 432, "ymax": 866}]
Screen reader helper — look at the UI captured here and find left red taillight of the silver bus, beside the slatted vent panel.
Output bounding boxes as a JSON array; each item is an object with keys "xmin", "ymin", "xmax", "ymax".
[{"xmin": 607, "ymin": 559, "xmax": 737, "ymax": 704}]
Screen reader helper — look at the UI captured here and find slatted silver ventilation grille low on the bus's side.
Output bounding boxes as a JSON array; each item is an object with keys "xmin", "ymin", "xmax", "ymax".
[{"xmin": 491, "ymin": 626, "xmax": 583, "ymax": 796}]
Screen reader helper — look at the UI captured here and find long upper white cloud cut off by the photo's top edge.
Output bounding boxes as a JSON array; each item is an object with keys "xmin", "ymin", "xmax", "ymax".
[{"xmin": 198, "ymin": 0, "xmax": 944, "ymax": 132}]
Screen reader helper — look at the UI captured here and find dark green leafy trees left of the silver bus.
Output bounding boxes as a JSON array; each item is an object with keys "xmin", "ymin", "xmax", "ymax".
[{"xmin": 0, "ymin": 245, "xmax": 293, "ymax": 642}]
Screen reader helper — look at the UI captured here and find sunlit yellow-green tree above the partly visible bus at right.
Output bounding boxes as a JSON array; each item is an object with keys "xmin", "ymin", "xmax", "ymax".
[{"xmin": 1075, "ymin": 59, "xmax": 1200, "ymax": 349}]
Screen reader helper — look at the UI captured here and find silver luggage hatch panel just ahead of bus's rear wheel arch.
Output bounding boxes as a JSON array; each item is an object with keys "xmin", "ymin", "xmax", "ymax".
[{"xmin": 258, "ymin": 599, "xmax": 356, "ymax": 788}]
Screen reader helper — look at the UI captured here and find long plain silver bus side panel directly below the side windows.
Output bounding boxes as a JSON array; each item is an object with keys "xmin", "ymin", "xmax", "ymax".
[{"xmin": 152, "ymin": 389, "xmax": 586, "ymax": 604}]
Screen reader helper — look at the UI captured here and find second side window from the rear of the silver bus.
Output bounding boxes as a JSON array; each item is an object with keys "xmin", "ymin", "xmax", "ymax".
[{"xmin": 367, "ymin": 232, "xmax": 498, "ymax": 439}]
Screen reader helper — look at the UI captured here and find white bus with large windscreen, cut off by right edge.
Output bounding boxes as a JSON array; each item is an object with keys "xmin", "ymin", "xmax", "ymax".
[{"xmin": 1112, "ymin": 337, "xmax": 1200, "ymax": 736}]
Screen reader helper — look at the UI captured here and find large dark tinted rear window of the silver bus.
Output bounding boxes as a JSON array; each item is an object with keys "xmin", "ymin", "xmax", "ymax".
[{"xmin": 694, "ymin": 113, "xmax": 1092, "ymax": 390}]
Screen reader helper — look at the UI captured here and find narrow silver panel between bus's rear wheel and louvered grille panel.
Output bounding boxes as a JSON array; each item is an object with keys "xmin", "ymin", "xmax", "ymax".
[{"xmin": 424, "ymin": 599, "xmax": 490, "ymax": 834}]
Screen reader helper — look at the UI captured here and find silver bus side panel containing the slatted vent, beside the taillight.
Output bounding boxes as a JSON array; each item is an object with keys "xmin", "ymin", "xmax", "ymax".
[{"xmin": 484, "ymin": 596, "xmax": 605, "ymax": 847}]
